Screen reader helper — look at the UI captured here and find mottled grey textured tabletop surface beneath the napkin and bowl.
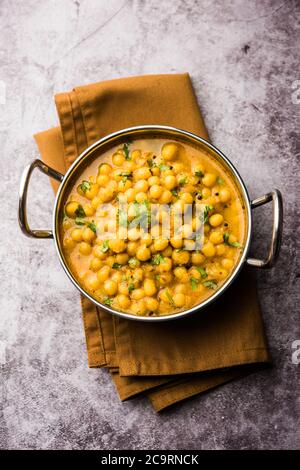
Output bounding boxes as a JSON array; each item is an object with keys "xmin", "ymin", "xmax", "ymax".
[{"xmin": 0, "ymin": 0, "xmax": 300, "ymax": 449}]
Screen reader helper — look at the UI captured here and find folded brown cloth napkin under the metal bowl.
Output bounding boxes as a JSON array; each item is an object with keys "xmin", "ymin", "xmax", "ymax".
[{"xmin": 35, "ymin": 74, "xmax": 269, "ymax": 411}]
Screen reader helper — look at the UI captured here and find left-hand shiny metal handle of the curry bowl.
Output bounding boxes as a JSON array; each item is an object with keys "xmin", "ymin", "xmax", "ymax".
[{"xmin": 19, "ymin": 159, "xmax": 64, "ymax": 238}]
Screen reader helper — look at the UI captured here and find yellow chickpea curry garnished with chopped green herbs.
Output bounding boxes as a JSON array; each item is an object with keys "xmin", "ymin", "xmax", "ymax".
[{"xmin": 60, "ymin": 138, "xmax": 247, "ymax": 316}]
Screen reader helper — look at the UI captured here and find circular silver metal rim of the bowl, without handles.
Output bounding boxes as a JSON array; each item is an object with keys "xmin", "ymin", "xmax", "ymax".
[{"xmin": 52, "ymin": 124, "xmax": 252, "ymax": 322}]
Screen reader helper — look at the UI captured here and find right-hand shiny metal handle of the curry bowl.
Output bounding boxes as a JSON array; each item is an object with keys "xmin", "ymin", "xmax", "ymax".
[{"xmin": 246, "ymin": 189, "xmax": 283, "ymax": 268}]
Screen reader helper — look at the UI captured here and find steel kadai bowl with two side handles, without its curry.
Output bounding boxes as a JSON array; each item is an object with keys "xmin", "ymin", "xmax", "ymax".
[{"xmin": 19, "ymin": 125, "xmax": 283, "ymax": 322}]
